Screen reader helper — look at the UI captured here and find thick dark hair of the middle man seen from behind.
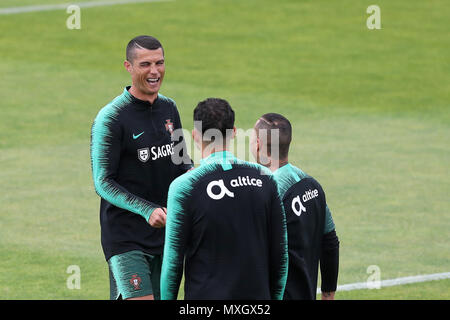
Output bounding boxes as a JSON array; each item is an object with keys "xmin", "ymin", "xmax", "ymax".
[{"xmin": 194, "ymin": 98, "xmax": 234, "ymax": 139}]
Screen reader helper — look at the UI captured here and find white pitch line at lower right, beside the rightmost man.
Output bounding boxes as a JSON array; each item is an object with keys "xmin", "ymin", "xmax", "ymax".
[{"xmin": 317, "ymin": 272, "xmax": 450, "ymax": 294}]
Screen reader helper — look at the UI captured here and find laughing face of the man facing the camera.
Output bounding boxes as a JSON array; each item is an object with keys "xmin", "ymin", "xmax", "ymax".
[{"xmin": 124, "ymin": 48, "xmax": 166, "ymax": 102}]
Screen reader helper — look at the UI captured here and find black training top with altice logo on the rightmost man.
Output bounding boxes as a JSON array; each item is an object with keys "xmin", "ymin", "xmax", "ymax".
[{"xmin": 274, "ymin": 163, "xmax": 338, "ymax": 300}]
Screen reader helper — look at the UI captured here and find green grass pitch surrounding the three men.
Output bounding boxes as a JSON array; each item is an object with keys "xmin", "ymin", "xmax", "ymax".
[{"xmin": 0, "ymin": 0, "xmax": 450, "ymax": 299}]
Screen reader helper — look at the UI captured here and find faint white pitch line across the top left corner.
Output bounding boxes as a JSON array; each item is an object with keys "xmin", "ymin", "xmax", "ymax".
[{"xmin": 0, "ymin": 0, "xmax": 175, "ymax": 15}]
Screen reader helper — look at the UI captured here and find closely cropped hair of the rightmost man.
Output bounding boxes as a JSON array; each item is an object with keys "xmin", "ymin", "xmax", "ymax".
[{"xmin": 255, "ymin": 113, "xmax": 292, "ymax": 159}]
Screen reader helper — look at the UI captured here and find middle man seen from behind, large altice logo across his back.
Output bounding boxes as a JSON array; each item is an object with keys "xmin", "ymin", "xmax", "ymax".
[{"xmin": 161, "ymin": 98, "xmax": 288, "ymax": 300}]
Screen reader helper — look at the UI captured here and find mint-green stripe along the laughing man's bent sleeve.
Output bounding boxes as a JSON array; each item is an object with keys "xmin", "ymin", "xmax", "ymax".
[{"xmin": 91, "ymin": 94, "xmax": 155, "ymax": 221}]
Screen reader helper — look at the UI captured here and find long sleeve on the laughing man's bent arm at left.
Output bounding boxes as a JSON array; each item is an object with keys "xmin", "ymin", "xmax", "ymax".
[{"xmin": 91, "ymin": 104, "xmax": 159, "ymax": 221}]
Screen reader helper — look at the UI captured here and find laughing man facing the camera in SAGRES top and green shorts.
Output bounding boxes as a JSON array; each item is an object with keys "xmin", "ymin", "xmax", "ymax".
[{"xmin": 91, "ymin": 36, "xmax": 192, "ymax": 299}]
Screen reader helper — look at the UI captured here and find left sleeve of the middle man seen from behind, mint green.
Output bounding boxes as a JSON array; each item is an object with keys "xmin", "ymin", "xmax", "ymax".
[{"xmin": 160, "ymin": 177, "xmax": 189, "ymax": 300}]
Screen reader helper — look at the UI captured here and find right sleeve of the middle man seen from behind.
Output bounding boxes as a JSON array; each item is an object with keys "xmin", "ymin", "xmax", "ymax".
[{"xmin": 269, "ymin": 179, "xmax": 289, "ymax": 300}]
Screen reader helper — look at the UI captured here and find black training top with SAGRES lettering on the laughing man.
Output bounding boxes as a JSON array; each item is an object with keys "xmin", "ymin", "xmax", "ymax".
[{"xmin": 91, "ymin": 87, "xmax": 192, "ymax": 260}]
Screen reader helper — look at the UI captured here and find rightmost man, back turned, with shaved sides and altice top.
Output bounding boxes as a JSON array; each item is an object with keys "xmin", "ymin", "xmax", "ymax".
[{"xmin": 250, "ymin": 113, "xmax": 339, "ymax": 300}]
